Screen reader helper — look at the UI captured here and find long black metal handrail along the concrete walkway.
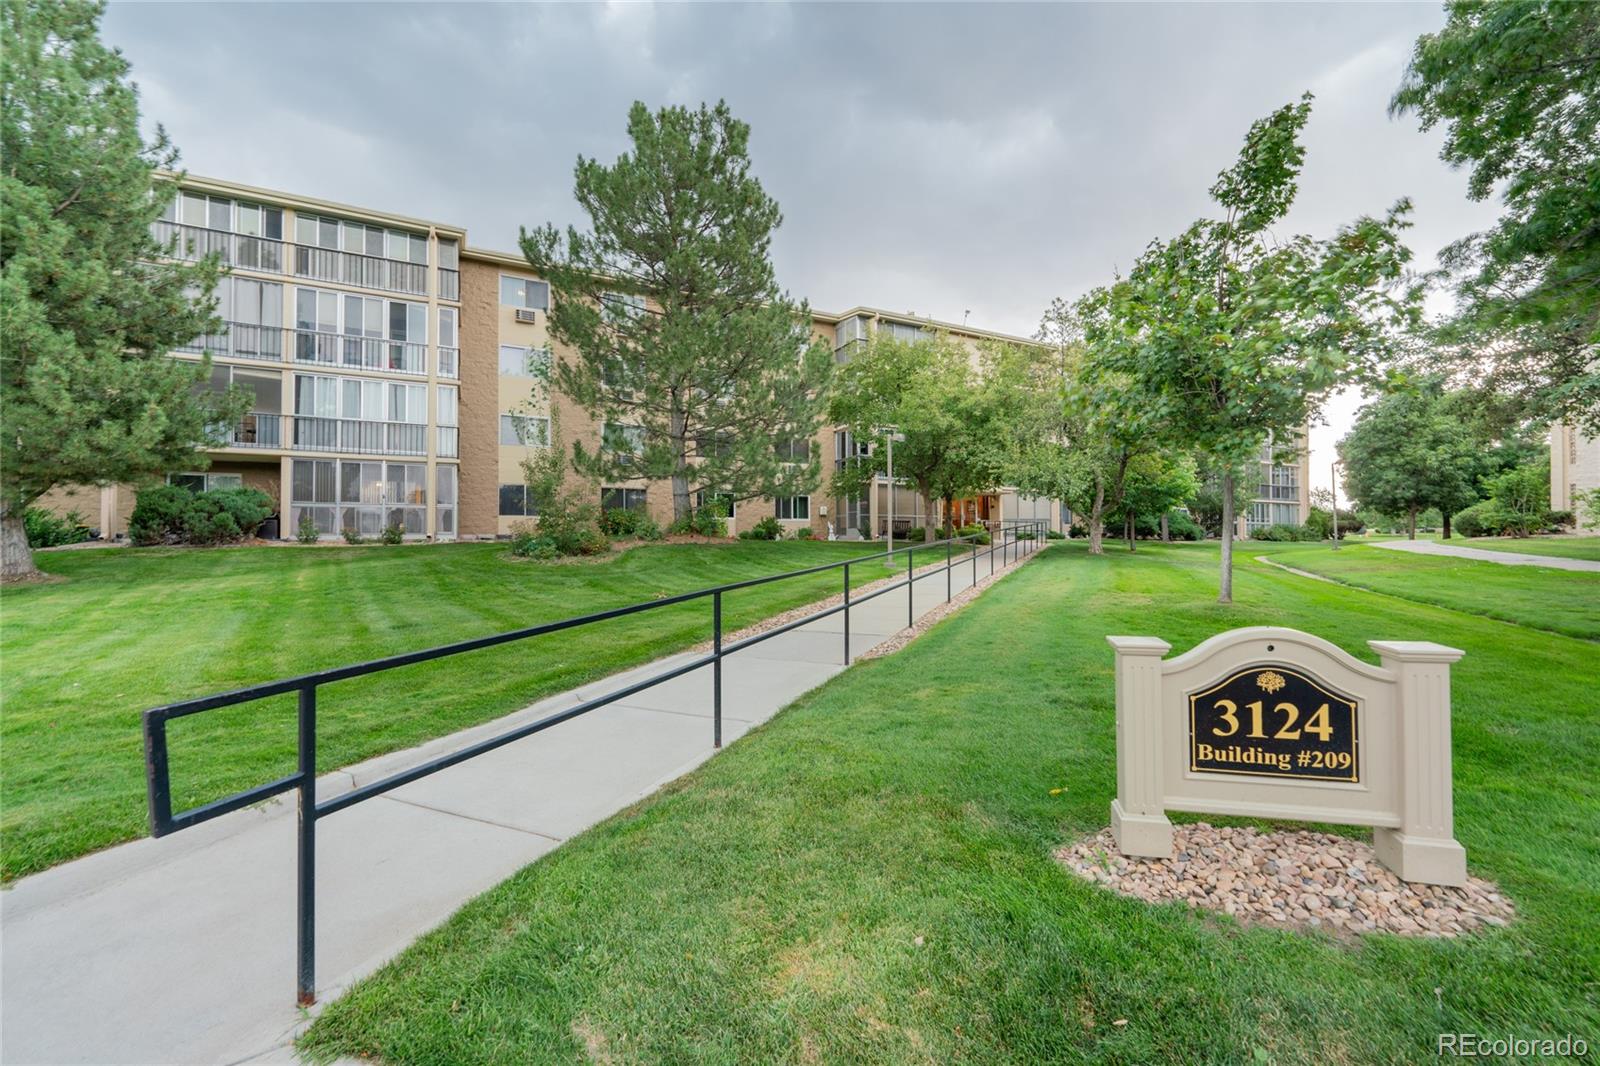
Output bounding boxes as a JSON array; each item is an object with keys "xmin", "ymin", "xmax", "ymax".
[{"xmin": 142, "ymin": 520, "xmax": 1046, "ymax": 1005}]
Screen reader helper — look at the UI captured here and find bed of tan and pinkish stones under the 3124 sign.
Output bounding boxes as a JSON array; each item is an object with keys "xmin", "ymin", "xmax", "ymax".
[{"xmin": 1056, "ymin": 823, "xmax": 1515, "ymax": 936}]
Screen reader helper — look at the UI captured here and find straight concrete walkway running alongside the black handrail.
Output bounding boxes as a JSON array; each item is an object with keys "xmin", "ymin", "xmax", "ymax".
[{"xmin": 0, "ymin": 543, "xmax": 1027, "ymax": 1063}]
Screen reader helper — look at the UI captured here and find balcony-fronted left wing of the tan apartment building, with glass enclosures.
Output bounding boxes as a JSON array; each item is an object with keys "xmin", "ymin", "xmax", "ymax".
[{"xmin": 46, "ymin": 178, "xmax": 466, "ymax": 539}]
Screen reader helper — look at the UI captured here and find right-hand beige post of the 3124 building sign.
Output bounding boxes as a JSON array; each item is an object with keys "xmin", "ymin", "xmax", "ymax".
[{"xmin": 1366, "ymin": 640, "xmax": 1467, "ymax": 885}]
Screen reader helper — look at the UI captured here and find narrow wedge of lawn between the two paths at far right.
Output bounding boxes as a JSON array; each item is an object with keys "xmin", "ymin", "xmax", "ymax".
[{"xmin": 1246, "ymin": 541, "xmax": 1600, "ymax": 640}]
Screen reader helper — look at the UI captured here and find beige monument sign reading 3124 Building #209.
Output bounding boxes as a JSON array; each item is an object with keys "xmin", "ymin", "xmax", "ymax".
[{"xmin": 1107, "ymin": 626, "xmax": 1467, "ymax": 885}]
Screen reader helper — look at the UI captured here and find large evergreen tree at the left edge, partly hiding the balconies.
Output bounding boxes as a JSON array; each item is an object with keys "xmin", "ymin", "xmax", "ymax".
[{"xmin": 0, "ymin": 0, "xmax": 242, "ymax": 579}]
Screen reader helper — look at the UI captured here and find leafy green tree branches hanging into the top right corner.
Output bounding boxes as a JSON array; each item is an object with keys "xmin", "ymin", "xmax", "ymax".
[{"xmin": 1389, "ymin": 0, "xmax": 1600, "ymax": 432}]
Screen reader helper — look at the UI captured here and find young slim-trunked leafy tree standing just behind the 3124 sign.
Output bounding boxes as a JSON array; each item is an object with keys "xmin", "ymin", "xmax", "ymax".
[{"xmin": 1086, "ymin": 93, "xmax": 1418, "ymax": 603}]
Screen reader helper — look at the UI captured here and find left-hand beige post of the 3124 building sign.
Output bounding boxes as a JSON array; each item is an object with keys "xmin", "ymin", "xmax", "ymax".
[{"xmin": 1106, "ymin": 637, "xmax": 1173, "ymax": 858}]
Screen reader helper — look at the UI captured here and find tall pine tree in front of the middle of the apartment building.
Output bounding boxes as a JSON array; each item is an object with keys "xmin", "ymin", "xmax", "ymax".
[{"xmin": 522, "ymin": 102, "xmax": 832, "ymax": 520}]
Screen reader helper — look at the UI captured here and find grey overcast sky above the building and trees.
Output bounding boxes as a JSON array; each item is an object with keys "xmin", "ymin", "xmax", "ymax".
[{"xmin": 104, "ymin": 2, "xmax": 1496, "ymax": 485}]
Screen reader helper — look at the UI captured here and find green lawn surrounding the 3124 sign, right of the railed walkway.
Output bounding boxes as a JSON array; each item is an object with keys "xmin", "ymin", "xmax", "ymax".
[{"xmin": 304, "ymin": 544, "xmax": 1600, "ymax": 1064}]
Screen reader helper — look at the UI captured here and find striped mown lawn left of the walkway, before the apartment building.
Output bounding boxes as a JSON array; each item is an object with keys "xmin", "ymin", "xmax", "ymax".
[{"xmin": 0, "ymin": 541, "xmax": 885, "ymax": 879}]
